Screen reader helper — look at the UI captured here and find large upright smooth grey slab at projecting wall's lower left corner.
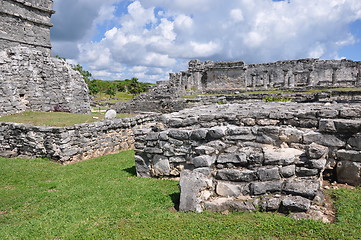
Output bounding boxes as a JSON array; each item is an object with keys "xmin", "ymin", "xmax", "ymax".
[{"xmin": 179, "ymin": 170, "xmax": 213, "ymax": 212}]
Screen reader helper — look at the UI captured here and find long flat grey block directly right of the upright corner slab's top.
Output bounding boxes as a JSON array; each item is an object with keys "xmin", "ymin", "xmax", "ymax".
[{"xmin": 216, "ymin": 169, "xmax": 258, "ymax": 182}]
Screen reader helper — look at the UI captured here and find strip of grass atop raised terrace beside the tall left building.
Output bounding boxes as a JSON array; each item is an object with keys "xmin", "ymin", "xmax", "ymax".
[{"xmin": 0, "ymin": 112, "xmax": 134, "ymax": 127}]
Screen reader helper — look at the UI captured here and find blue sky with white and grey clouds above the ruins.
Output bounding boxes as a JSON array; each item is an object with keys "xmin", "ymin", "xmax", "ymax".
[{"xmin": 51, "ymin": 0, "xmax": 361, "ymax": 82}]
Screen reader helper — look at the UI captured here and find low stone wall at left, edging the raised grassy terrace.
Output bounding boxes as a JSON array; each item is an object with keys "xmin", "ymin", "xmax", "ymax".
[{"xmin": 0, "ymin": 115, "xmax": 155, "ymax": 164}]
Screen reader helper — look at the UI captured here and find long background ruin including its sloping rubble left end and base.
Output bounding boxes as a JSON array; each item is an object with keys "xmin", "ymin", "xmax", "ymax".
[{"xmin": 116, "ymin": 59, "xmax": 361, "ymax": 113}]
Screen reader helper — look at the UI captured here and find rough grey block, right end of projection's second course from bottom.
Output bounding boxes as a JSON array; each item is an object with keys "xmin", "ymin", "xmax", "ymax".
[{"xmin": 282, "ymin": 179, "xmax": 320, "ymax": 199}]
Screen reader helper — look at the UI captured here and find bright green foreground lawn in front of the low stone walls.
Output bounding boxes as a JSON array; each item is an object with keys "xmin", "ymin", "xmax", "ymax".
[{"xmin": 0, "ymin": 151, "xmax": 361, "ymax": 239}]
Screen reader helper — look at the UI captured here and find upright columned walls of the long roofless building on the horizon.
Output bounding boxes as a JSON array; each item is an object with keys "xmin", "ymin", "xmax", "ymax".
[{"xmin": 170, "ymin": 59, "xmax": 361, "ymax": 92}]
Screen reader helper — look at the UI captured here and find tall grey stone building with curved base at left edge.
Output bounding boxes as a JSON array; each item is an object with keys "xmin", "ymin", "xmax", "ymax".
[{"xmin": 0, "ymin": 0, "xmax": 90, "ymax": 116}]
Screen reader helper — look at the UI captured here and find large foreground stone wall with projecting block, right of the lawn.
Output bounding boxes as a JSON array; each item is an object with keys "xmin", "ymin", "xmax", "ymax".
[{"xmin": 134, "ymin": 103, "xmax": 361, "ymax": 217}]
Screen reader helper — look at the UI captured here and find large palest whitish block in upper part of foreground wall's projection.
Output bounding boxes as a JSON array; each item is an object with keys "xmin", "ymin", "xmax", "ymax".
[{"xmin": 263, "ymin": 146, "xmax": 304, "ymax": 165}]
